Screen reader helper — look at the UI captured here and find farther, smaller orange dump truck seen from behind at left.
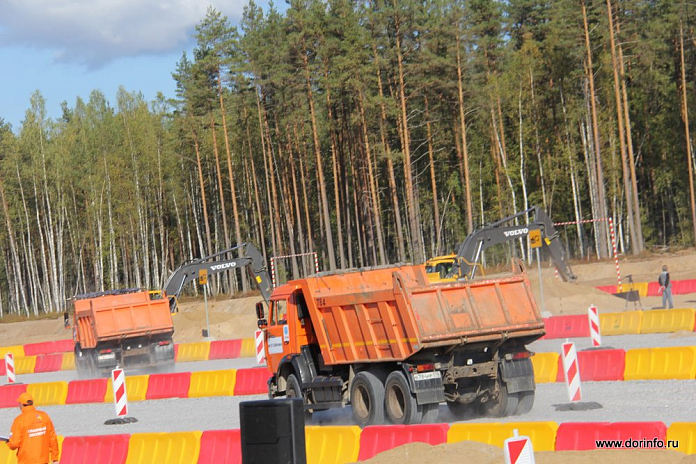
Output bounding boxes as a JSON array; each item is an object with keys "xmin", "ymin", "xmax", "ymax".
[{"xmin": 73, "ymin": 289, "xmax": 174, "ymax": 377}]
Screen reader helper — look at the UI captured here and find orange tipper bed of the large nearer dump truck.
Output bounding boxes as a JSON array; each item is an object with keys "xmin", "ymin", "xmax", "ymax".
[{"xmin": 301, "ymin": 266, "xmax": 544, "ymax": 365}]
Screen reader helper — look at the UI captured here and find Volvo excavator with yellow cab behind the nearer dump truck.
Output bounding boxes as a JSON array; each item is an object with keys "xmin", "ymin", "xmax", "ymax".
[{"xmin": 425, "ymin": 206, "xmax": 577, "ymax": 282}]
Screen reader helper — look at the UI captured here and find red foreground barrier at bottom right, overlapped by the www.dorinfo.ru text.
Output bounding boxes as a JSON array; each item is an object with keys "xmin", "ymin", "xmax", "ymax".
[{"xmin": 556, "ymin": 422, "xmax": 667, "ymax": 451}]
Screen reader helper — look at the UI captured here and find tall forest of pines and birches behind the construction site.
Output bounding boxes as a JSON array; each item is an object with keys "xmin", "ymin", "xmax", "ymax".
[{"xmin": 0, "ymin": 0, "xmax": 696, "ymax": 315}]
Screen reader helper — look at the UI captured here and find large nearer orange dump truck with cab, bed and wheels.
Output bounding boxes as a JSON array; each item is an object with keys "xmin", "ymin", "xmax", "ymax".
[{"xmin": 256, "ymin": 263, "xmax": 544, "ymax": 426}]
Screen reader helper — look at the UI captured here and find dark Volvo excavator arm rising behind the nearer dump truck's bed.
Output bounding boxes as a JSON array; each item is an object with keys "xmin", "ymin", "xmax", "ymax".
[{"xmin": 448, "ymin": 206, "xmax": 577, "ymax": 282}]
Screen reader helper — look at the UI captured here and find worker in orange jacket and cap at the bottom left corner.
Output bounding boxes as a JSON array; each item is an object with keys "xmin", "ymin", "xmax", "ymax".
[{"xmin": 7, "ymin": 393, "xmax": 60, "ymax": 464}]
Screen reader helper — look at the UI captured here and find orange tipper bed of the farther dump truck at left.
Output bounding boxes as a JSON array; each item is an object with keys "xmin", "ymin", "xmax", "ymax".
[{"xmin": 75, "ymin": 292, "xmax": 174, "ymax": 348}]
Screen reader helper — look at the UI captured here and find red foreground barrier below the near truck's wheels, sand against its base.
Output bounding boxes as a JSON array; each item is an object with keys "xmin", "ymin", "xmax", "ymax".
[{"xmin": 358, "ymin": 424, "xmax": 449, "ymax": 461}]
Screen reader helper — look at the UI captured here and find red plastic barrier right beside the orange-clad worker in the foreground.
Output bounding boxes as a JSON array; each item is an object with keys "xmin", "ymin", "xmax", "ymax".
[{"xmin": 60, "ymin": 434, "xmax": 130, "ymax": 464}]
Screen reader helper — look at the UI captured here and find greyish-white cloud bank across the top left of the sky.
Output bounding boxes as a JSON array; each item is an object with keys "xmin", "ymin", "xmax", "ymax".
[{"xmin": 0, "ymin": 0, "xmax": 248, "ymax": 68}]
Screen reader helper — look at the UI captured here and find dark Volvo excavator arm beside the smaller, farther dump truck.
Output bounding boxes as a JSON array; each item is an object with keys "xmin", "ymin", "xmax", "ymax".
[{"xmin": 164, "ymin": 243, "xmax": 271, "ymax": 311}]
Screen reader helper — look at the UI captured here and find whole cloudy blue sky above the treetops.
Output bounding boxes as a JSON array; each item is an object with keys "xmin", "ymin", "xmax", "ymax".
[{"xmin": 0, "ymin": 0, "xmax": 278, "ymax": 131}]
